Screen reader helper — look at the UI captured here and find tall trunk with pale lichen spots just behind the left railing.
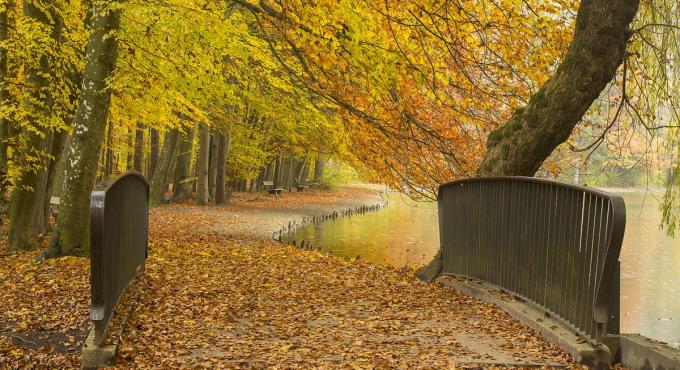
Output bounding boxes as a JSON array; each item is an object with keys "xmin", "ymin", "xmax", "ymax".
[{"xmin": 48, "ymin": 1, "xmax": 121, "ymax": 255}]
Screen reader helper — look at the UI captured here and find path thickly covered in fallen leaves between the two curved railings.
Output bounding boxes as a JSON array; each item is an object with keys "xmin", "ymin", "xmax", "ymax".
[{"xmin": 118, "ymin": 189, "xmax": 567, "ymax": 369}]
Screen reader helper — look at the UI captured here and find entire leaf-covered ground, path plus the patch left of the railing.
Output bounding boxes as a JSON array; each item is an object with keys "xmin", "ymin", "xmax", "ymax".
[{"xmin": 0, "ymin": 188, "xmax": 574, "ymax": 369}]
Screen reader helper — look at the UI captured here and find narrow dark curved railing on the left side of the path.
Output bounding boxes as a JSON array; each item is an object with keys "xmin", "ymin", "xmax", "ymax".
[{"xmin": 90, "ymin": 172, "xmax": 149, "ymax": 345}]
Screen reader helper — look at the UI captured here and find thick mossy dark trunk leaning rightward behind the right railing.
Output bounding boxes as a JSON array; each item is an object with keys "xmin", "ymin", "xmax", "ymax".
[{"xmin": 478, "ymin": 0, "xmax": 639, "ymax": 176}]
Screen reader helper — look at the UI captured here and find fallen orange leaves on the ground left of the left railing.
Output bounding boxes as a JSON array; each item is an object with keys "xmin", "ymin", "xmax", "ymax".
[{"xmin": 0, "ymin": 240, "xmax": 89, "ymax": 368}]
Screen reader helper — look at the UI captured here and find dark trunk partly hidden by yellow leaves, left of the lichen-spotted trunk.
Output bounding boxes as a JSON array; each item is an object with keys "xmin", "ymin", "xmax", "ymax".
[{"xmin": 6, "ymin": 0, "xmax": 62, "ymax": 250}]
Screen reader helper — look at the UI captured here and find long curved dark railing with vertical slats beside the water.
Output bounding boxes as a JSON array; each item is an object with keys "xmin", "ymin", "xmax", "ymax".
[{"xmin": 438, "ymin": 177, "xmax": 626, "ymax": 343}]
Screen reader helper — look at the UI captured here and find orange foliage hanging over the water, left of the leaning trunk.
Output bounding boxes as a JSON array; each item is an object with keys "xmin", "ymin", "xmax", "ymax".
[{"xmin": 250, "ymin": 0, "xmax": 575, "ymax": 193}]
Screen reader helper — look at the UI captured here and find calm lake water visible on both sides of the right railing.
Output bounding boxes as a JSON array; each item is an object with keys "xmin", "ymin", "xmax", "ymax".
[{"xmin": 288, "ymin": 191, "xmax": 680, "ymax": 345}]
